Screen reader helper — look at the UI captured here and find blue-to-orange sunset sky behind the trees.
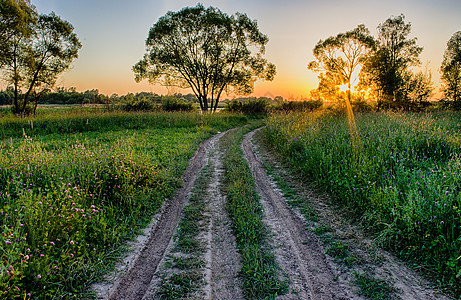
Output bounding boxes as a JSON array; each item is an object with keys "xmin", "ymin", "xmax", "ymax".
[{"xmin": 31, "ymin": 0, "xmax": 461, "ymax": 100}]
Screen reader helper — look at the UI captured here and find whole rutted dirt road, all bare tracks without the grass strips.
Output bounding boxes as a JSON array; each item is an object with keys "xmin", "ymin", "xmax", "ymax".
[{"xmin": 96, "ymin": 127, "xmax": 452, "ymax": 299}]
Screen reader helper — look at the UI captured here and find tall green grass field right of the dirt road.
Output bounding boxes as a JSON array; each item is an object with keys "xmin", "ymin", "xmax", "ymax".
[{"xmin": 266, "ymin": 112, "xmax": 461, "ymax": 296}]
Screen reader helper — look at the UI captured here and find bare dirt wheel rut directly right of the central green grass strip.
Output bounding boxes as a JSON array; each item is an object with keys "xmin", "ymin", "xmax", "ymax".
[{"xmin": 242, "ymin": 129, "xmax": 355, "ymax": 299}]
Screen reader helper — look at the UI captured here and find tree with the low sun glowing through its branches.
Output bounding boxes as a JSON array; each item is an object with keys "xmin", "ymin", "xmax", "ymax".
[{"xmin": 308, "ymin": 24, "xmax": 375, "ymax": 102}]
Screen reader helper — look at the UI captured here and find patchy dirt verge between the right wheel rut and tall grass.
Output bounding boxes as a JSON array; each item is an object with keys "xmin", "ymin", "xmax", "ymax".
[{"xmin": 247, "ymin": 127, "xmax": 451, "ymax": 300}]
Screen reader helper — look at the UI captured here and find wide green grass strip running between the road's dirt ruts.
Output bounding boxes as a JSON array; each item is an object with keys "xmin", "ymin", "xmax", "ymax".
[{"xmin": 221, "ymin": 125, "xmax": 288, "ymax": 299}]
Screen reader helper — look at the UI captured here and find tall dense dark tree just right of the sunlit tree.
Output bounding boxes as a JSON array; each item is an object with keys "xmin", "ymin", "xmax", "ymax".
[{"xmin": 360, "ymin": 15, "xmax": 423, "ymax": 106}]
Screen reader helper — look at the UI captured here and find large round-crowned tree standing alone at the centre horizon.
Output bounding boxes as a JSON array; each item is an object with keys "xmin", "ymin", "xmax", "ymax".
[{"xmin": 133, "ymin": 4, "xmax": 276, "ymax": 111}]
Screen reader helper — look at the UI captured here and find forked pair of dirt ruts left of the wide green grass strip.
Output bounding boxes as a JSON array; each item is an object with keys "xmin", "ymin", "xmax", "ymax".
[{"xmin": 100, "ymin": 133, "xmax": 243, "ymax": 300}]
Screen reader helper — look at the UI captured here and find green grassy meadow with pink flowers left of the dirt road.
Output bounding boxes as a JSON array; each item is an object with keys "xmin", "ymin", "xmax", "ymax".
[{"xmin": 0, "ymin": 111, "xmax": 247, "ymax": 299}]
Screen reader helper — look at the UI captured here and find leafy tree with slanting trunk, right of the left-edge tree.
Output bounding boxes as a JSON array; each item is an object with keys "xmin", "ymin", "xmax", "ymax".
[{"xmin": 21, "ymin": 12, "xmax": 82, "ymax": 114}]
